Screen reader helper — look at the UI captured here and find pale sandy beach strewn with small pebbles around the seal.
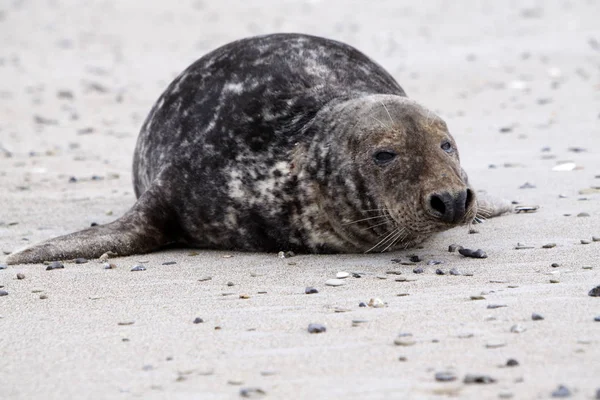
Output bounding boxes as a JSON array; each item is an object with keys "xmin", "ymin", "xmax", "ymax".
[{"xmin": 0, "ymin": 0, "xmax": 600, "ymax": 399}]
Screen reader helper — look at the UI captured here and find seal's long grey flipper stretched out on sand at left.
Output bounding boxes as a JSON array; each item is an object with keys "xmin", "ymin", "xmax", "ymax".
[{"xmin": 6, "ymin": 185, "xmax": 177, "ymax": 264}]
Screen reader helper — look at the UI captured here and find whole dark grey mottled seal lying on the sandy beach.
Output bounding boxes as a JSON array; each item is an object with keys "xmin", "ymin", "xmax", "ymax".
[{"xmin": 7, "ymin": 34, "xmax": 506, "ymax": 263}]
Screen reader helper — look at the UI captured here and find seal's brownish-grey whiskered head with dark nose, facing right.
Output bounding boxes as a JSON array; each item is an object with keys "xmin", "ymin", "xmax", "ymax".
[{"xmin": 312, "ymin": 95, "xmax": 477, "ymax": 251}]
